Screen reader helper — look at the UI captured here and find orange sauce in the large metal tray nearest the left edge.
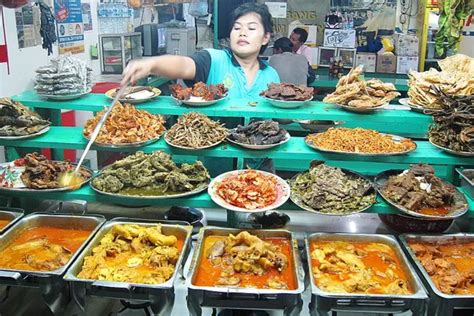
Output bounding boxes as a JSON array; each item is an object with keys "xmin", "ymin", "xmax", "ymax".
[{"xmin": 0, "ymin": 226, "xmax": 91, "ymax": 270}]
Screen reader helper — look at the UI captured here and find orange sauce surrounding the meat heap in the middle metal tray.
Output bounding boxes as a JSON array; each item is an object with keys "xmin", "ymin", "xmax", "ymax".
[{"xmin": 193, "ymin": 236, "xmax": 296, "ymax": 290}]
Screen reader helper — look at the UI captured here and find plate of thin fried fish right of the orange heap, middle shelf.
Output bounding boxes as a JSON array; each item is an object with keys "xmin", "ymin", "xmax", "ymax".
[{"xmin": 165, "ymin": 112, "xmax": 228, "ymax": 150}]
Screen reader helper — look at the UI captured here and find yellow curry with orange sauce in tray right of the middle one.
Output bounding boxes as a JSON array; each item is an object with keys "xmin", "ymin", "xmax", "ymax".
[{"xmin": 310, "ymin": 241, "xmax": 413, "ymax": 295}]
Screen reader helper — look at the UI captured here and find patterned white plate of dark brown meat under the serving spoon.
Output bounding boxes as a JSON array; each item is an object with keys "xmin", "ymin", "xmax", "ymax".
[{"xmin": 0, "ymin": 153, "xmax": 93, "ymax": 192}]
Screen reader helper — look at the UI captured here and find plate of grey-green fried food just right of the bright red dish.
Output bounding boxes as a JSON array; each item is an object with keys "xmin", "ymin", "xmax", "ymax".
[{"xmin": 288, "ymin": 161, "xmax": 376, "ymax": 216}]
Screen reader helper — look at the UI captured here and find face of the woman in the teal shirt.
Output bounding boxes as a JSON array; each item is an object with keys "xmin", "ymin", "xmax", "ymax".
[{"xmin": 230, "ymin": 13, "xmax": 270, "ymax": 58}]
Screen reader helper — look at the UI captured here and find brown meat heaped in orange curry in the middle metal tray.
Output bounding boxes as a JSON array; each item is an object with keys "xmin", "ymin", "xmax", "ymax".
[{"xmin": 193, "ymin": 231, "xmax": 296, "ymax": 290}]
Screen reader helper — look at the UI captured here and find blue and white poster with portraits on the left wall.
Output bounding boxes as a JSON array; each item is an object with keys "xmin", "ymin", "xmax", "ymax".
[{"xmin": 54, "ymin": 0, "xmax": 84, "ymax": 54}]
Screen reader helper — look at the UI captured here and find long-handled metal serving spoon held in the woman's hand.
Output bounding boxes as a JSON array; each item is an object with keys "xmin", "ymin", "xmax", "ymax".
[{"xmin": 58, "ymin": 85, "xmax": 128, "ymax": 188}]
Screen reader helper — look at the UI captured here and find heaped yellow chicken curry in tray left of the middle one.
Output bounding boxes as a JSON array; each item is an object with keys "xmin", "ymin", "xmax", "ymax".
[{"xmin": 78, "ymin": 224, "xmax": 184, "ymax": 284}]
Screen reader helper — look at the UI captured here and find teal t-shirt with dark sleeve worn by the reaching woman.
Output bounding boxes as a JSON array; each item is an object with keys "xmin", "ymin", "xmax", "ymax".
[{"xmin": 191, "ymin": 49, "xmax": 280, "ymax": 98}]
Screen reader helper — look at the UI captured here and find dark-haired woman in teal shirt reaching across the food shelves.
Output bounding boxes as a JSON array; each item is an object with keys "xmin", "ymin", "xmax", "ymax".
[{"xmin": 122, "ymin": 3, "xmax": 280, "ymax": 98}]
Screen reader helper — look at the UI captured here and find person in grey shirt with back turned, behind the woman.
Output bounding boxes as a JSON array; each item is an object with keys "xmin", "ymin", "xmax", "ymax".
[{"xmin": 269, "ymin": 37, "xmax": 315, "ymax": 85}]
